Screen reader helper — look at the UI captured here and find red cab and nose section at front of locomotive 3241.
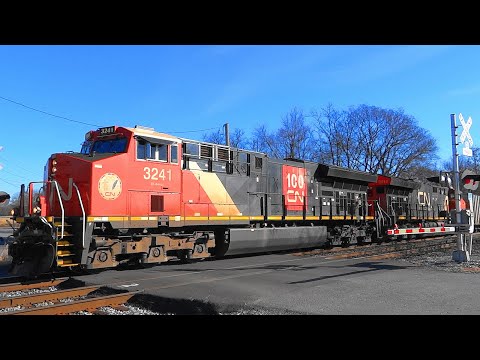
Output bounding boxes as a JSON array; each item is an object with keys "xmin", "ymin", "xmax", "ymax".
[{"xmin": 9, "ymin": 126, "xmax": 187, "ymax": 276}]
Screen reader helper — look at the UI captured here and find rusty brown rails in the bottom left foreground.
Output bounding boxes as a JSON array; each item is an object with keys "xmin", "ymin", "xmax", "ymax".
[{"xmin": 0, "ymin": 278, "xmax": 138, "ymax": 315}]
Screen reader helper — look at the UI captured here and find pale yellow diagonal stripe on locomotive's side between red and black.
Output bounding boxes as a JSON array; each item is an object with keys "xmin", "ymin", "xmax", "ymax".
[{"xmin": 190, "ymin": 162, "xmax": 240, "ymax": 216}]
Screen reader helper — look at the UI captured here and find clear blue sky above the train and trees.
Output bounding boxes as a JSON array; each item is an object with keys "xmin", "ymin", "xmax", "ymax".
[{"xmin": 0, "ymin": 45, "xmax": 480, "ymax": 194}]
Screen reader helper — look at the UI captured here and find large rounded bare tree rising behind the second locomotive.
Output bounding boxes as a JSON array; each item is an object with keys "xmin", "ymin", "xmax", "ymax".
[{"xmin": 312, "ymin": 105, "xmax": 437, "ymax": 176}]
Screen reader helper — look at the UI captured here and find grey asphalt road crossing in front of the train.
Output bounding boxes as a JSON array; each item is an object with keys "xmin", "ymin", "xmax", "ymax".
[{"xmin": 0, "ymin": 229, "xmax": 480, "ymax": 315}]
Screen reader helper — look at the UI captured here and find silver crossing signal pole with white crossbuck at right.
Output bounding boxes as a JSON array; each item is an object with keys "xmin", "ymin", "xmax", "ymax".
[{"xmin": 450, "ymin": 114, "xmax": 471, "ymax": 262}]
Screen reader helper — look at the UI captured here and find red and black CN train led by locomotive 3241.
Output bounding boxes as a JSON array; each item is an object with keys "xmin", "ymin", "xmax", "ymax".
[{"xmin": 9, "ymin": 126, "xmax": 453, "ymax": 276}]
